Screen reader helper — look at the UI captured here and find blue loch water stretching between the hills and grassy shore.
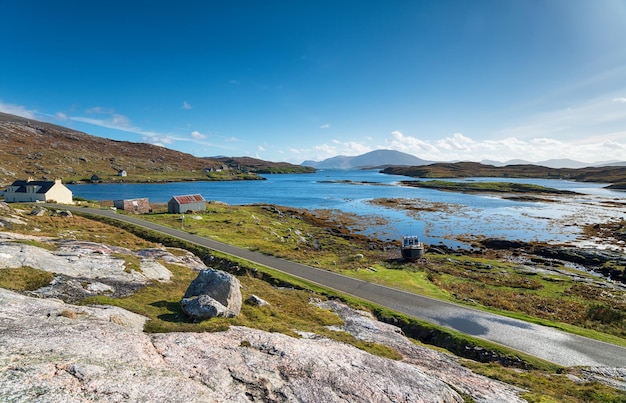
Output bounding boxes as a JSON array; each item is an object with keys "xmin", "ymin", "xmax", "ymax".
[{"xmin": 68, "ymin": 170, "xmax": 626, "ymax": 247}]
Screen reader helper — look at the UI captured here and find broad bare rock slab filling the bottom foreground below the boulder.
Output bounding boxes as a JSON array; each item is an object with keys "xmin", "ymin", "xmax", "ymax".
[{"xmin": 0, "ymin": 289, "xmax": 463, "ymax": 403}]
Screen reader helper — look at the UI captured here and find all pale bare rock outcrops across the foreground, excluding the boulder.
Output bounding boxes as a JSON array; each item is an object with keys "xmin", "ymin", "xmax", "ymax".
[{"xmin": 0, "ymin": 232, "xmax": 523, "ymax": 402}]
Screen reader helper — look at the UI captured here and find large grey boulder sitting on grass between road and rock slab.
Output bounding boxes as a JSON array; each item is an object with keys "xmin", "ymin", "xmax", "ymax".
[{"xmin": 180, "ymin": 268, "xmax": 242, "ymax": 320}]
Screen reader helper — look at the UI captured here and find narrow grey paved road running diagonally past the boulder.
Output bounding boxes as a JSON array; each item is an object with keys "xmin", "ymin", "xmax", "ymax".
[{"xmin": 57, "ymin": 206, "xmax": 626, "ymax": 367}]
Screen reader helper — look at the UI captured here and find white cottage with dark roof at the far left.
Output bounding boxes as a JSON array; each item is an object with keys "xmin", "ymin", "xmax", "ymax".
[{"xmin": 4, "ymin": 178, "xmax": 72, "ymax": 204}]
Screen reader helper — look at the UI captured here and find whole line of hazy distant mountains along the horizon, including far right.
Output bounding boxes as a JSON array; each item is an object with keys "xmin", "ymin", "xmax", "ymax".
[{"xmin": 300, "ymin": 150, "xmax": 626, "ymax": 169}]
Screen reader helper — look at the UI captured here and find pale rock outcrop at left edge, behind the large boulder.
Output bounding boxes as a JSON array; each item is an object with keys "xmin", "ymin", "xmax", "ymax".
[{"xmin": 0, "ymin": 237, "xmax": 206, "ymax": 302}]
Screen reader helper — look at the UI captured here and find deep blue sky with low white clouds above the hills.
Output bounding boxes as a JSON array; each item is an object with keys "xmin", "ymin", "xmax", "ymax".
[{"xmin": 0, "ymin": 0, "xmax": 626, "ymax": 163}]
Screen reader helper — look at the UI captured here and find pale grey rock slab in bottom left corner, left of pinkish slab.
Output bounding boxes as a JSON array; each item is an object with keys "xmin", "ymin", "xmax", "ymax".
[{"xmin": 0, "ymin": 289, "xmax": 214, "ymax": 403}]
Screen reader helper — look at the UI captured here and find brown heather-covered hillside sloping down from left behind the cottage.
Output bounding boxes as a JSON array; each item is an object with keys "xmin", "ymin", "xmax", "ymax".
[{"xmin": 0, "ymin": 113, "xmax": 306, "ymax": 187}]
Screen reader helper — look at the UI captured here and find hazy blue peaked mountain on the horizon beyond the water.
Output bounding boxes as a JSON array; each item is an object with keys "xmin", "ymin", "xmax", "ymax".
[{"xmin": 300, "ymin": 150, "xmax": 434, "ymax": 169}]
